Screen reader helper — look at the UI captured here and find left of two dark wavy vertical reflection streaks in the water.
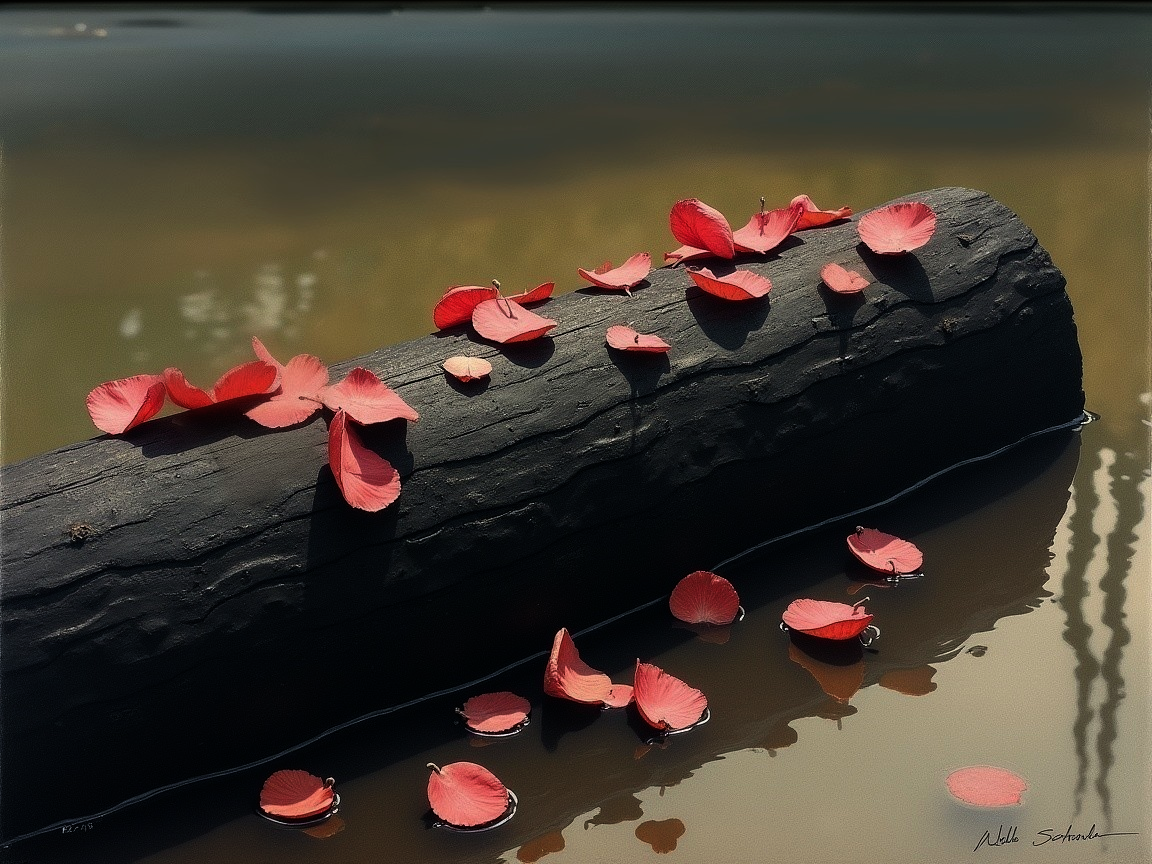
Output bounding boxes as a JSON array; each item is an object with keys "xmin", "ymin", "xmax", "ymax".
[{"xmin": 1060, "ymin": 449, "xmax": 1101, "ymax": 816}]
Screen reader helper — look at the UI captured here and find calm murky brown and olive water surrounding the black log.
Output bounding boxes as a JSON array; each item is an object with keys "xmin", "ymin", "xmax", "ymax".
[{"xmin": 0, "ymin": 7, "xmax": 1152, "ymax": 864}]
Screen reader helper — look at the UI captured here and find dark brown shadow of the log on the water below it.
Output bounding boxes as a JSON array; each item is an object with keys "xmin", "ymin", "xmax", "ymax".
[{"xmin": 4, "ymin": 433, "xmax": 1082, "ymax": 863}]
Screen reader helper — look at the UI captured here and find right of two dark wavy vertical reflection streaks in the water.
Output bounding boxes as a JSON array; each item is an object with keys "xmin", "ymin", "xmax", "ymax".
[{"xmin": 1096, "ymin": 456, "xmax": 1144, "ymax": 831}]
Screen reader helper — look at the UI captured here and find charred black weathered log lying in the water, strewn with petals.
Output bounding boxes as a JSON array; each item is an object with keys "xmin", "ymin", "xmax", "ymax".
[{"xmin": 0, "ymin": 189, "xmax": 1083, "ymax": 838}]
